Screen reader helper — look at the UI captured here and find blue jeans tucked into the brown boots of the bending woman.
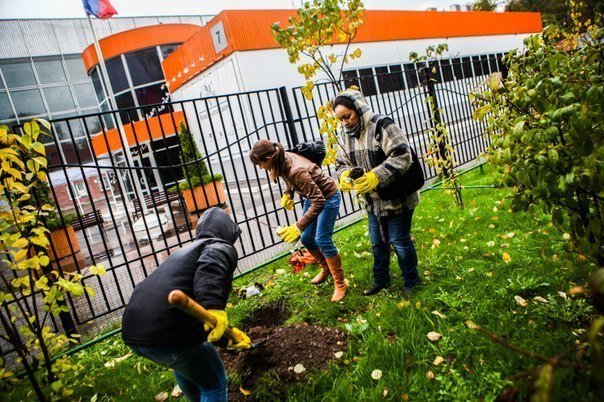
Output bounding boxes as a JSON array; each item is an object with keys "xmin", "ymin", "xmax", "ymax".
[{"xmin": 300, "ymin": 191, "xmax": 341, "ymax": 258}]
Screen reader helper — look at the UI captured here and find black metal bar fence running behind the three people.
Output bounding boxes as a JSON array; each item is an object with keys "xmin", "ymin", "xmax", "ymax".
[{"xmin": 0, "ymin": 54, "xmax": 505, "ymax": 355}]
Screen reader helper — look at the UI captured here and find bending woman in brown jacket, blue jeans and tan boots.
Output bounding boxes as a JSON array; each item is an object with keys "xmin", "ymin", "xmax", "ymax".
[{"xmin": 250, "ymin": 140, "xmax": 347, "ymax": 302}]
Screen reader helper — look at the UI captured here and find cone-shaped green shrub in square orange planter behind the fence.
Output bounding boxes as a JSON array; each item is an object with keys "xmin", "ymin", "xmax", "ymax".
[{"xmin": 169, "ymin": 122, "xmax": 226, "ymax": 213}]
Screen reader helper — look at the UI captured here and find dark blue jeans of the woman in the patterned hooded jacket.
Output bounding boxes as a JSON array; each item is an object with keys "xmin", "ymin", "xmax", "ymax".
[{"xmin": 368, "ymin": 209, "xmax": 421, "ymax": 289}]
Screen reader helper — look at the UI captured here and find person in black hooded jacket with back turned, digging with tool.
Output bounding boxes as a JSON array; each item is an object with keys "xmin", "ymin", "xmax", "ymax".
[{"xmin": 122, "ymin": 207, "xmax": 251, "ymax": 402}]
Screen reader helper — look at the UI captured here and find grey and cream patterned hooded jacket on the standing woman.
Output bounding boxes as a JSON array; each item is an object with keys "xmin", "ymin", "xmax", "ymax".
[{"xmin": 336, "ymin": 89, "xmax": 419, "ymax": 217}]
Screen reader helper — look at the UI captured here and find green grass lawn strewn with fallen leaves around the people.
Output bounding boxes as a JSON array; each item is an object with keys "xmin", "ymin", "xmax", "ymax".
[{"xmin": 5, "ymin": 164, "xmax": 595, "ymax": 401}]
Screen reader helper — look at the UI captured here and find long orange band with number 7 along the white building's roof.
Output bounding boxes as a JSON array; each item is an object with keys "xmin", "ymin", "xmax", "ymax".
[{"xmin": 163, "ymin": 10, "xmax": 543, "ymax": 91}]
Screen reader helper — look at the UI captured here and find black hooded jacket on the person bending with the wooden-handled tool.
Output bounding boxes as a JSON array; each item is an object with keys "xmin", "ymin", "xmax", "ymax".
[{"xmin": 122, "ymin": 207, "xmax": 241, "ymax": 346}]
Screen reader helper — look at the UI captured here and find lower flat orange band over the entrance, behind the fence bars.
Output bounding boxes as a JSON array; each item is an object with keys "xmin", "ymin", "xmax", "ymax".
[{"xmin": 92, "ymin": 111, "xmax": 185, "ymax": 156}]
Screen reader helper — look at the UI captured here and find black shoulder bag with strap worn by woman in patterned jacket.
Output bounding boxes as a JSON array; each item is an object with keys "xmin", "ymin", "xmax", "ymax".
[{"xmin": 375, "ymin": 115, "xmax": 424, "ymax": 201}]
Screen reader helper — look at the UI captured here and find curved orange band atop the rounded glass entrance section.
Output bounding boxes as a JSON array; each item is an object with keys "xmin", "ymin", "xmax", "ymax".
[{"xmin": 82, "ymin": 24, "xmax": 201, "ymax": 71}]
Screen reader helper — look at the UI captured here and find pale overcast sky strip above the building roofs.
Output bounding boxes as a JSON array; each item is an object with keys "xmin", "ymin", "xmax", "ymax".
[{"xmin": 0, "ymin": 0, "xmax": 473, "ymax": 19}]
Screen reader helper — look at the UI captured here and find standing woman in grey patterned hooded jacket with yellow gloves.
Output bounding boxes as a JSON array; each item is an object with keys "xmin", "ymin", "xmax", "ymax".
[{"xmin": 332, "ymin": 89, "xmax": 421, "ymax": 296}]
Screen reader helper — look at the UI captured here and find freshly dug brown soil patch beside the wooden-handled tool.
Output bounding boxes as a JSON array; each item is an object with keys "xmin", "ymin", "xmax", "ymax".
[{"xmin": 221, "ymin": 325, "xmax": 347, "ymax": 401}]
